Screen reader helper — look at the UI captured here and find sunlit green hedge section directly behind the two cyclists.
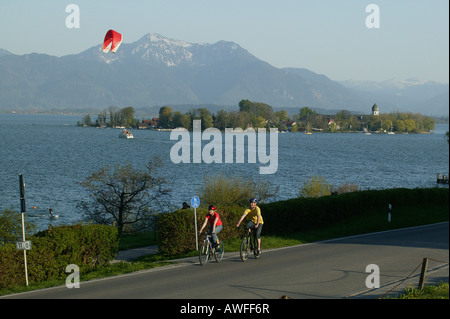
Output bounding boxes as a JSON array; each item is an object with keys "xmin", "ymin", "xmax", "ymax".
[{"xmin": 158, "ymin": 207, "xmax": 244, "ymax": 255}]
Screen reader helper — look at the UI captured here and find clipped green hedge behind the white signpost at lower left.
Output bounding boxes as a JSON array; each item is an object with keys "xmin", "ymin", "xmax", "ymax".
[{"xmin": 0, "ymin": 224, "xmax": 119, "ymax": 288}]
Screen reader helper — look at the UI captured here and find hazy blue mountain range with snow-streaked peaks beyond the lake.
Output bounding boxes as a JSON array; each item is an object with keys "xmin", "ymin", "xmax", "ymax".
[{"xmin": 0, "ymin": 33, "xmax": 449, "ymax": 116}]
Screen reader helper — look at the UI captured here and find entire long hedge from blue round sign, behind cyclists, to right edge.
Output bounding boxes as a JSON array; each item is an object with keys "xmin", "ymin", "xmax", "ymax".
[{"xmin": 158, "ymin": 188, "xmax": 449, "ymax": 255}]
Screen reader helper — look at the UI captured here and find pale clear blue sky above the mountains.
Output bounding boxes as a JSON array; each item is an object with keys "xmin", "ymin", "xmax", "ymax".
[{"xmin": 0, "ymin": 0, "xmax": 449, "ymax": 83}]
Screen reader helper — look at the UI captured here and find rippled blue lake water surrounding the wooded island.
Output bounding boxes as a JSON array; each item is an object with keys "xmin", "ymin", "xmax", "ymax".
[{"xmin": 0, "ymin": 114, "xmax": 449, "ymax": 229}]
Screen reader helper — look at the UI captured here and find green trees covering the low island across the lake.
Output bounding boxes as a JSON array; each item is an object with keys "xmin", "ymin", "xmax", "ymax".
[{"xmin": 78, "ymin": 100, "xmax": 436, "ymax": 133}]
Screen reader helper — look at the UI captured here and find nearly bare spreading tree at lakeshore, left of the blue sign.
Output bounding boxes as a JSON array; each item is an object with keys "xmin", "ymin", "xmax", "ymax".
[{"xmin": 79, "ymin": 157, "xmax": 169, "ymax": 235}]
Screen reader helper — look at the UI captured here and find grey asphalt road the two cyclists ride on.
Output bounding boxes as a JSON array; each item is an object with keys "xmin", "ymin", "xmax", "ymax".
[{"xmin": 4, "ymin": 223, "xmax": 449, "ymax": 299}]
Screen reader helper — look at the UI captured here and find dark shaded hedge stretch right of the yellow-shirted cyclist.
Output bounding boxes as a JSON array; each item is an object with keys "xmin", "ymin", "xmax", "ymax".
[{"xmin": 259, "ymin": 188, "xmax": 449, "ymax": 235}]
